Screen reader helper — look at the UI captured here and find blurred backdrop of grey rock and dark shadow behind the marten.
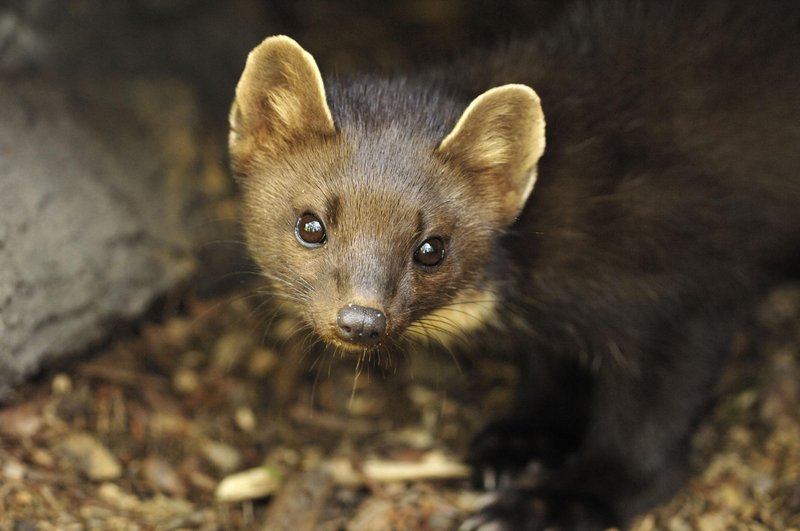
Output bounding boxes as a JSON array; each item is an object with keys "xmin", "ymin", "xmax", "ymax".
[{"xmin": 0, "ymin": 0, "xmax": 564, "ymax": 400}]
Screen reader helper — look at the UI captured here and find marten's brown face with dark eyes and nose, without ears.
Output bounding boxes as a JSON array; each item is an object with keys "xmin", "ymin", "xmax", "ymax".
[{"xmin": 238, "ymin": 125, "xmax": 496, "ymax": 349}]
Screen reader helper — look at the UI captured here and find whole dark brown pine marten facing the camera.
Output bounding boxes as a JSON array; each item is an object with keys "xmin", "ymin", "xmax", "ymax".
[{"xmin": 229, "ymin": 1, "xmax": 800, "ymax": 529}]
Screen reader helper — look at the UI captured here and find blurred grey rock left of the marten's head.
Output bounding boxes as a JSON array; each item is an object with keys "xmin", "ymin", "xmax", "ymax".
[{"xmin": 0, "ymin": 80, "xmax": 224, "ymax": 398}]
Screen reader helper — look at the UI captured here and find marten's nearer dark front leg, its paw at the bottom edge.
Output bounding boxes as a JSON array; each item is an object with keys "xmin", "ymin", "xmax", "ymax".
[{"xmin": 462, "ymin": 322, "xmax": 727, "ymax": 531}]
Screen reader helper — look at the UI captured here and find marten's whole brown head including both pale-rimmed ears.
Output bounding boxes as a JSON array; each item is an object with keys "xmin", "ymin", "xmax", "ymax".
[{"xmin": 229, "ymin": 36, "xmax": 544, "ymax": 353}]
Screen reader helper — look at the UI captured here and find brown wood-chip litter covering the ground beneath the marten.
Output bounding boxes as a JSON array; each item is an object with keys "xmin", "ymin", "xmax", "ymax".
[{"xmin": 0, "ymin": 286, "xmax": 800, "ymax": 531}]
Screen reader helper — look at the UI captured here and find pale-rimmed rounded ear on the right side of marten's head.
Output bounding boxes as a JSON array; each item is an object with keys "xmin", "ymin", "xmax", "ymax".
[{"xmin": 438, "ymin": 85, "xmax": 545, "ymax": 224}]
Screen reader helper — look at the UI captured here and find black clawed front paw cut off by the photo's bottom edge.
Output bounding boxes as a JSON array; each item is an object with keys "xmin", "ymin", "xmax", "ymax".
[{"xmin": 459, "ymin": 489, "xmax": 617, "ymax": 531}]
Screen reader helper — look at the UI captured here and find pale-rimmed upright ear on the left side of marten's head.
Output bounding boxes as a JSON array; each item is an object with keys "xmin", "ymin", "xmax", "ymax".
[{"xmin": 228, "ymin": 35, "xmax": 336, "ymax": 159}]
